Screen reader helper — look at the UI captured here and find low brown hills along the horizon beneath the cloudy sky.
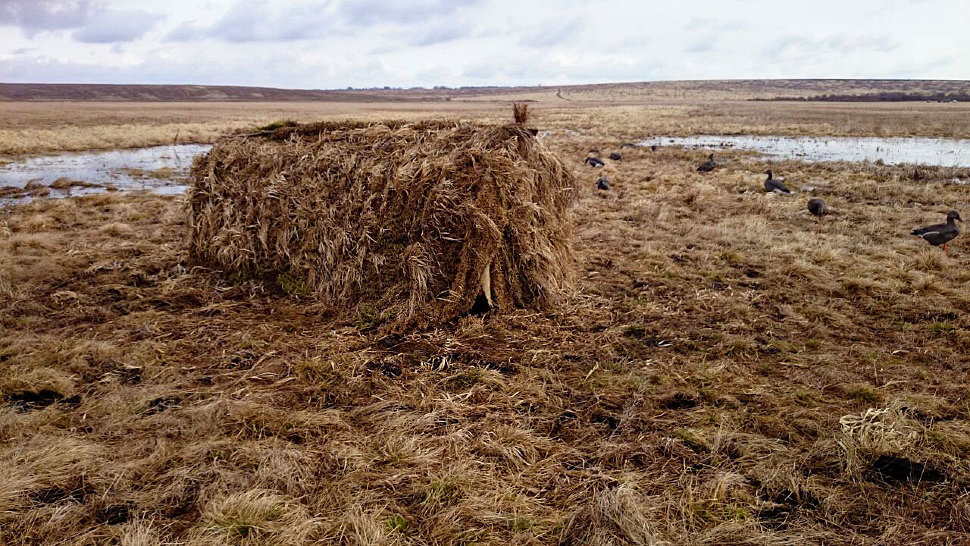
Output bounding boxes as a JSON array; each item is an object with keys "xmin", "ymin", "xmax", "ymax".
[{"xmin": 0, "ymin": 79, "xmax": 970, "ymax": 103}]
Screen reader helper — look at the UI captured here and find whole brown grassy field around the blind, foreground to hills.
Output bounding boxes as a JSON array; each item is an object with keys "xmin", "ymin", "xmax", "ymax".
[{"xmin": 0, "ymin": 99, "xmax": 970, "ymax": 545}]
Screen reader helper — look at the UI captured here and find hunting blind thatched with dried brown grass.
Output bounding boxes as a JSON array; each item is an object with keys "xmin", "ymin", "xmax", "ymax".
[{"xmin": 190, "ymin": 122, "xmax": 575, "ymax": 326}]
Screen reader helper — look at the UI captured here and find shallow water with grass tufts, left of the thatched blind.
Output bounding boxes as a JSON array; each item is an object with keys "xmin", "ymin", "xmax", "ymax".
[{"xmin": 0, "ymin": 144, "xmax": 210, "ymax": 204}]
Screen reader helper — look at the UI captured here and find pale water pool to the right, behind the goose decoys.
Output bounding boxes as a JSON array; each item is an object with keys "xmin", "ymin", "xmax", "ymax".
[{"xmin": 640, "ymin": 135, "xmax": 970, "ymax": 167}]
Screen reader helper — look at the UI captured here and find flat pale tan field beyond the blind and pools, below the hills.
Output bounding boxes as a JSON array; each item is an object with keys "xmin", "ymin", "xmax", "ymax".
[{"xmin": 0, "ymin": 95, "xmax": 970, "ymax": 156}]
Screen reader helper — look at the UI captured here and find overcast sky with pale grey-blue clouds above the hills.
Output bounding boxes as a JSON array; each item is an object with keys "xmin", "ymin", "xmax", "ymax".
[{"xmin": 0, "ymin": 0, "xmax": 970, "ymax": 88}]
